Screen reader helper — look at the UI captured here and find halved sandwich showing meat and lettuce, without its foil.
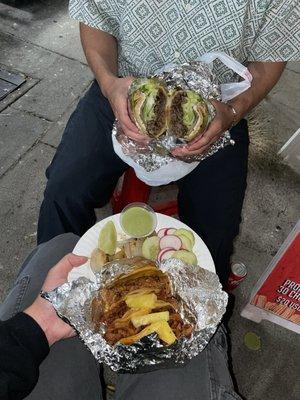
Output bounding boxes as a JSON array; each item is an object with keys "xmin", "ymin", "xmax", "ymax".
[{"xmin": 129, "ymin": 78, "xmax": 211, "ymax": 142}]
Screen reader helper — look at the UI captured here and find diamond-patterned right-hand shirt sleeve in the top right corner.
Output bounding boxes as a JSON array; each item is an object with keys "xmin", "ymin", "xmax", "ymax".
[{"xmin": 248, "ymin": 0, "xmax": 300, "ymax": 61}]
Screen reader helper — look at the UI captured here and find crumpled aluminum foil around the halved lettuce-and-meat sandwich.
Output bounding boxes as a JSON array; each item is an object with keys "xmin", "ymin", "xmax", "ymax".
[{"xmin": 112, "ymin": 61, "xmax": 234, "ymax": 172}]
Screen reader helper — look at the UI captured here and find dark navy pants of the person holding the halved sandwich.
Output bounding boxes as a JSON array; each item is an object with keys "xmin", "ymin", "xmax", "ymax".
[{"xmin": 38, "ymin": 82, "xmax": 249, "ymax": 282}]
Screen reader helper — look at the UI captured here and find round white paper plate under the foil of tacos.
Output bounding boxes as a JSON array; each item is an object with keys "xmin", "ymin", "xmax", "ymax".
[{"xmin": 68, "ymin": 213, "xmax": 215, "ymax": 282}]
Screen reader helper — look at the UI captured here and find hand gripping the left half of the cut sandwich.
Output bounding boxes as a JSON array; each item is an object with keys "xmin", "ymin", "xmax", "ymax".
[{"xmin": 105, "ymin": 76, "xmax": 148, "ymax": 142}]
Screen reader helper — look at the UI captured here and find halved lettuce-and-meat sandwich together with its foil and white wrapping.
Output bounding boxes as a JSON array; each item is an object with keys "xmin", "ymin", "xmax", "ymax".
[{"xmin": 112, "ymin": 61, "xmax": 234, "ymax": 177}]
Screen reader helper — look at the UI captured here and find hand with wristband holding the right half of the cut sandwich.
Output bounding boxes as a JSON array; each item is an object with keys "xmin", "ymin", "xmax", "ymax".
[{"xmin": 172, "ymin": 100, "xmax": 234, "ymax": 157}]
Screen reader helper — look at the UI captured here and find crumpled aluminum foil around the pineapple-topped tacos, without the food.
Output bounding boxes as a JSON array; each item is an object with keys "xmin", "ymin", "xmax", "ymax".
[{"xmin": 43, "ymin": 259, "xmax": 227, "ymax": 373}]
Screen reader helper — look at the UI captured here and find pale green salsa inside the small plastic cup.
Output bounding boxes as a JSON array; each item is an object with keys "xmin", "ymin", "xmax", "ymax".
[{"xmin": 121, "ymin": 207, "xmax": 154, "ymax": 238}]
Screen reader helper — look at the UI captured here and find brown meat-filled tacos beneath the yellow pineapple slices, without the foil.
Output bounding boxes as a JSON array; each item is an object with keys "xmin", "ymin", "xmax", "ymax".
[{"xmin": 91, "ymin": 257, "xmax": 192, "ymax": 345}]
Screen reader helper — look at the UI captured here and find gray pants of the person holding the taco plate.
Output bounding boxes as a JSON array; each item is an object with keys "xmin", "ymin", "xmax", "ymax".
[{"xmin": 0, "ymin": 234, "xmax": 241, "ymax": 400}]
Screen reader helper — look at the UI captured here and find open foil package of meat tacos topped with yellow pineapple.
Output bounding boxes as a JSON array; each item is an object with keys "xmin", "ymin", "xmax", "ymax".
[{"xmin": 44, "ymin": 259, "xmax": 227, "ymax": 373}]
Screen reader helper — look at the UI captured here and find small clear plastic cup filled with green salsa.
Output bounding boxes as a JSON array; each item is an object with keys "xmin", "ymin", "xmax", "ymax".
[{"xmin": 120, "ymin": 203, "xmax": 157, "ymax": 238}]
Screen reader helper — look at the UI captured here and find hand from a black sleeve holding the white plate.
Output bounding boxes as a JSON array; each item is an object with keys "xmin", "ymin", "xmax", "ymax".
[{"xmin": 24, "ymin": 253, "xmax": 87, "ymax": 346}]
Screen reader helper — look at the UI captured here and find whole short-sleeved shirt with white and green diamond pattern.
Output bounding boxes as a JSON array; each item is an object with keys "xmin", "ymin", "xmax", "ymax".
[{"xmin": 69, "ymin": 0, "xmax": 300, "ymax": 82}]
